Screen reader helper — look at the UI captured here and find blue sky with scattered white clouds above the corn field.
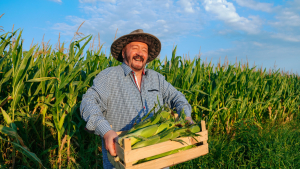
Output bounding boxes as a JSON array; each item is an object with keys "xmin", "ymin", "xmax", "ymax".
[{"xmin": 0, "ymin": 0, "xmax": 300, "ymax": 73}]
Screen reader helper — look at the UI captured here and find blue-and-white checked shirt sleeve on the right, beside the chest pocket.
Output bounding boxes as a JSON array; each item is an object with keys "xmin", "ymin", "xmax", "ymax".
[{"xmin": 160, "ymin": 76, "xmax": 192, "ymax": 117}]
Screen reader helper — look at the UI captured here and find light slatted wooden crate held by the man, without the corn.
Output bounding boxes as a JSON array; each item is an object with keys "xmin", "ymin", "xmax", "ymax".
[{"xmin": 107, "ymin": 121, "xmax": 208, "ymax": 169}]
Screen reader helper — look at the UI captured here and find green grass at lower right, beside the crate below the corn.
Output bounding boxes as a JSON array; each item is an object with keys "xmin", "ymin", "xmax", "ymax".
[{"xmin": 172, "ymin": 118, "xmax": 300, "ymax": 169}]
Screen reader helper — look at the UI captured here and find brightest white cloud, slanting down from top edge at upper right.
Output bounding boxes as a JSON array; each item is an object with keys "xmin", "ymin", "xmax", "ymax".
[{"xmin": 203, "ymin": 0, "xmax": 262, "ymax": 34}]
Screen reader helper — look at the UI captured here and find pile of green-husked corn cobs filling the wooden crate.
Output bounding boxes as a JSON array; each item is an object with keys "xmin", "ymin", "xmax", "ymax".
[{"xmin": 118, "ymin": 105, "xmax": 200, "ymax": 149}]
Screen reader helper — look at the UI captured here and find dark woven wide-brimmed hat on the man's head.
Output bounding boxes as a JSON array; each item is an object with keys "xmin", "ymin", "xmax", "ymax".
[{"xmin": 110, "ymin": 33, "xmax": 161, "ymax": 63}]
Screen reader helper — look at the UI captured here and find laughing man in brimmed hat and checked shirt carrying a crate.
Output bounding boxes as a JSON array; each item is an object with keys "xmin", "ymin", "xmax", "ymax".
[{"xmin": 80, "ymin": 29, "xmax": 193, "ymax": 169}]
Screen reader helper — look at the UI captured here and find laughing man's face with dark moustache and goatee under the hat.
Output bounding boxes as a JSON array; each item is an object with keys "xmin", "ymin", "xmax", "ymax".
[{"xmin": 122, "ymin": 42, "xmax": 148, "ymax": 71}]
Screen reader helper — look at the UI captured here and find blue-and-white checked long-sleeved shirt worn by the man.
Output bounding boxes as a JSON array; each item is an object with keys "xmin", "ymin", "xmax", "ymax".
[{"xmin": 80, "ymin": 63, "xmax": 191, "ymax": 168}]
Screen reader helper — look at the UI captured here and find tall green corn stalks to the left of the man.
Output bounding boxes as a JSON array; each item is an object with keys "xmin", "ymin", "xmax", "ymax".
[{"xmin": 0, "ymin": 31, "xmax": 120, "ymax": 168}]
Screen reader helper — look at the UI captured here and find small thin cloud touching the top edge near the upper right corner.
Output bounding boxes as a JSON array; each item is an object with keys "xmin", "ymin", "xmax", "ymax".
[{"xmin": 235, "ymin": 0, "xmax": 273, "ymax": 12}]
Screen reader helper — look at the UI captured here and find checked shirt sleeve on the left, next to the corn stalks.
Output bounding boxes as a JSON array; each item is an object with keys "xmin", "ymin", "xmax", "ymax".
[{"xmin": 80, "ymin": 71, "xmax": 112, "ymax": 137}]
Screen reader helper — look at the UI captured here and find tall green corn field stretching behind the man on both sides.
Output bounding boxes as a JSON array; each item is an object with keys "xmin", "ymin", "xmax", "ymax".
[{"xmin": 0, "ymin": 31, "xmax": 300, "ymax": 168}]
